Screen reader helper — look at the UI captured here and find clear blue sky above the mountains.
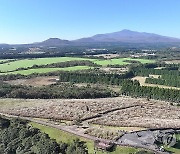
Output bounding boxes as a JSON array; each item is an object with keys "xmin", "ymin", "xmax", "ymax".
[{"xmin": 0, "ymin": 0, "xmax": 180, "ymax": 43}]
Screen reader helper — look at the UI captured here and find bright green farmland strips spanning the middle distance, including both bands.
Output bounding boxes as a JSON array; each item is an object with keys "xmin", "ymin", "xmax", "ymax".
[{"xmin": 0, "ymin": 57, "xmax": 155, "ymax": 75}]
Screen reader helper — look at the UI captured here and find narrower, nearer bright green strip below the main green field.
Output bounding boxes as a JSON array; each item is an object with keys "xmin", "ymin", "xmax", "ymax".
[{"xmin": 0, "ymin": 66, "xmax": 92, "ymax": 75}]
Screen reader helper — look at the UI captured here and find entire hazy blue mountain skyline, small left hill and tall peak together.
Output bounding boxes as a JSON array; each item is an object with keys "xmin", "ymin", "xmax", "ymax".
[{"xmin": 0, "ymin": 29, "xmax": 180, "ymax": 47}]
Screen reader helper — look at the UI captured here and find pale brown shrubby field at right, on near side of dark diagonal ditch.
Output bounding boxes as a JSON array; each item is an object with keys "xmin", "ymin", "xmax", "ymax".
[{"xmin": 91, "ymin": 103, "xmax": 180, "ymax": 128}]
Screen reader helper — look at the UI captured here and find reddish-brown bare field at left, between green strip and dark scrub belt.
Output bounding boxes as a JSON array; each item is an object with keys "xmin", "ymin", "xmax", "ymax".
[{"xmin": 5, "ymin": 76, "xmax": 58, "ymax": 86}]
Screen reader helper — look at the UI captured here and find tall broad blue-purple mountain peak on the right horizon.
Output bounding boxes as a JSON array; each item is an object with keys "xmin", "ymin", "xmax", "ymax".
[{"xmin": 77, "ymin": 29, "xmax": 180, "ymax": 43}]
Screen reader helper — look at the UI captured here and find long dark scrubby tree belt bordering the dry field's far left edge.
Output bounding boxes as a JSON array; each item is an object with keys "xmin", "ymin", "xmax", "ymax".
[{"xmin": 0, "ymin": 83, "xmax": 117, "ymax": 99}]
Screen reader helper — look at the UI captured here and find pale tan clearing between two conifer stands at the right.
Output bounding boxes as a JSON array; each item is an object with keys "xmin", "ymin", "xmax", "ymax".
[{"xmin": 132, "ymin": 75, "xmax": 180, "ymax": 90}]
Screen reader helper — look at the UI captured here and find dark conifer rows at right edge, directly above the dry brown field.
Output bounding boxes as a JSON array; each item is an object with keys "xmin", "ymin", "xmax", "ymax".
[{"xmin": 121, "ymin": 80, "xmax": 180, "ymax": 103}]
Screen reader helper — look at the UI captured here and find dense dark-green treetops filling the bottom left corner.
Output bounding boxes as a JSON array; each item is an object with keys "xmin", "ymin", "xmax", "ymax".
[{"xmin": 0, "ymin": 118, "xmax": 88, "ymax": 154}]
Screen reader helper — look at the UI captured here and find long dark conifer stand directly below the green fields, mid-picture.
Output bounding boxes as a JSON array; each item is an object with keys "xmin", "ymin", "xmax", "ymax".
[{"xmin": 59, "ymin": 72, "xmax": 133, "ymax": 85}]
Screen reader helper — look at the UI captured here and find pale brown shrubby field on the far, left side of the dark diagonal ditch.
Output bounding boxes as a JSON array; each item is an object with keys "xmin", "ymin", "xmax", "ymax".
[{"xmin": 0, "ymin": 97, "xmax": 139, "ymax": 120}]
